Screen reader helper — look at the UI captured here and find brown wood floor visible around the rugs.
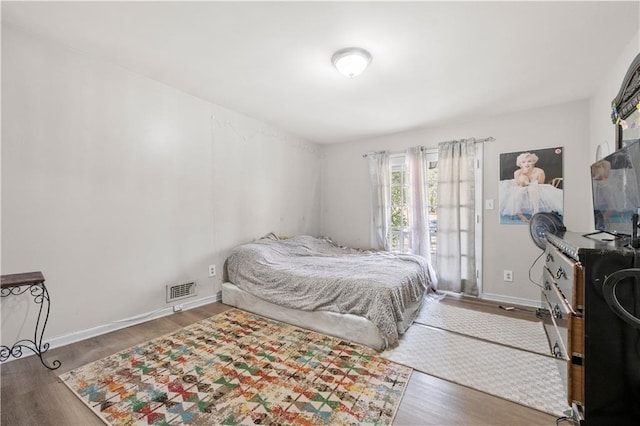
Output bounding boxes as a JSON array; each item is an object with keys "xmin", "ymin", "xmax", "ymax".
[{"xmin": 0, "ymin": 297, "xmax": 555, "ymax": 426}]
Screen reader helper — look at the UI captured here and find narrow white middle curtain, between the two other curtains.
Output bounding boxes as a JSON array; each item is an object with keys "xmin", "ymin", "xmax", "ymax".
[{"xmin": 405, "ymin": 146, "xmax": 436, "ymax": 287}]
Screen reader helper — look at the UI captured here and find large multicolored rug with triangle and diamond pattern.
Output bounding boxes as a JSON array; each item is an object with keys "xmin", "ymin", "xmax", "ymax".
[{"xmin": 60, "ymin": 309, "xmax": 412, "ymax": 425}]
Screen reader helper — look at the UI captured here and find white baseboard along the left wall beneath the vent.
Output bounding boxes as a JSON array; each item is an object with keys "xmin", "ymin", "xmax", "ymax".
[{"xmin": 4, "ymin": 292, "xmax": 221, "ymax": 362}]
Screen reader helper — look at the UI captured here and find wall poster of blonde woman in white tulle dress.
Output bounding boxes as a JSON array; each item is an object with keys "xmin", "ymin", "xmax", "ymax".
[{"xmin": 498, "ymin": 147, "xmax": 564, "ymax": 225}]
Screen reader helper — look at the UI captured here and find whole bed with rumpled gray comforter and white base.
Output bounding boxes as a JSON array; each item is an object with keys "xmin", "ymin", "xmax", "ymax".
[{"xmin": 222, "ymin": 234, "xmax": 435, "ymax": 350}]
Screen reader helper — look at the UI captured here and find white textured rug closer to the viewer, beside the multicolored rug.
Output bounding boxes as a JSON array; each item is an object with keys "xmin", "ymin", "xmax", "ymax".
[{"xmin": 381, "ymin": 310, "xmax": 569, "ymax": 417}]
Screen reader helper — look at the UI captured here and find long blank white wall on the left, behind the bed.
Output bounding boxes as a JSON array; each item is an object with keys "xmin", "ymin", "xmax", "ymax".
[{"xmin": 2, "ymin": 25, "xmax": 320, "ymax": 345}]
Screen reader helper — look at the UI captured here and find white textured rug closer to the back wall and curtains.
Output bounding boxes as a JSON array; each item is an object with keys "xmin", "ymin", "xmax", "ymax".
[{"xmin": 414, "ymin": 302, "xmax": 551, "ymax": 356}]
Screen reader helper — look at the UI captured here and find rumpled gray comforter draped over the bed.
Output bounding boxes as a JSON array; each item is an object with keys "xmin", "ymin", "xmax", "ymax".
[{"xmin": 227, "ymin": 235, "xmax": 433, "ymax": 345}]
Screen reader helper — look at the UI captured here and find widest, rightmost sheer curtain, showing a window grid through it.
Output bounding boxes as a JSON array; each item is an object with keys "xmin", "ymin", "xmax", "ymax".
[{"xmin": 437, "ymin": 139, "xmax": 478, "ymax": 296}]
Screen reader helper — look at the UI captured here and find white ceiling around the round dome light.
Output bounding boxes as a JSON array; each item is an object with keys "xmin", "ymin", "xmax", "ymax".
[{"xmin": 2, "ymin": 1, "xmax": 640, "ymax": 143}]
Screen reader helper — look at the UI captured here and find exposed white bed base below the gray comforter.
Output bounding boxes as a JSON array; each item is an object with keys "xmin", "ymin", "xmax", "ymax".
[{"xmin": 222, "ymin": 282, "xmax": 422, "ymax": 350}]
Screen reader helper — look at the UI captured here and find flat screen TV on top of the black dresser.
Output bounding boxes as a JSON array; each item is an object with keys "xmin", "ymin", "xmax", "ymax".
[{"xmin": 591, "ymin": 140, "xmax": 640, "ymax": 236}]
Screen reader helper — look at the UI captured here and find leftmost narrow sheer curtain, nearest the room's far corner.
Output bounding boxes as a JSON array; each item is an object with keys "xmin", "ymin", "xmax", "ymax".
[{"xmin": 367, "ymin": 151, "xmax": 391, "ymax": 250}]
